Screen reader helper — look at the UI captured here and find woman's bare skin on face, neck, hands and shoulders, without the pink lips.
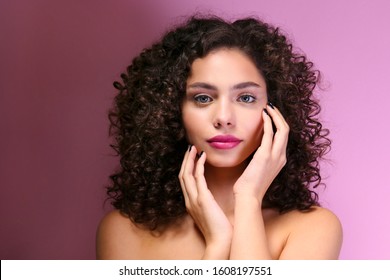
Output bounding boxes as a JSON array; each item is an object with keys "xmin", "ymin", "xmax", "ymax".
[{"xmin": 97, "ymin": 49, "xmax": 342, "ymax": 259}]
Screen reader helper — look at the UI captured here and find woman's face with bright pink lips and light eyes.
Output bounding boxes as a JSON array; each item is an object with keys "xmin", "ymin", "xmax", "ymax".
[{"xmin": 182, "ymin": 49, "xmax": 267, "ymax": 167}]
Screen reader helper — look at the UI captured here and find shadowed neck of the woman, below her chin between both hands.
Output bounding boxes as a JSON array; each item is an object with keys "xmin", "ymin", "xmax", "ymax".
[{"xmin": 205, "ymin": 163, "xmax": 247, "ymax": 217}]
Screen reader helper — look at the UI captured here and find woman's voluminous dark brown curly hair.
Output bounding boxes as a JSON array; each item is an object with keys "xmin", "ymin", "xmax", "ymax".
[{"xmin": 107, "ymin": 16, "xmax": 330, "ymax": 230}]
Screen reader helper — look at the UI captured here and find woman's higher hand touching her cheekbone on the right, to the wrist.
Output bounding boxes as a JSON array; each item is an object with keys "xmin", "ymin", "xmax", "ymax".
[{"xmin": 233, "ymin": 105, "xmax": 290, "ymax": 203}]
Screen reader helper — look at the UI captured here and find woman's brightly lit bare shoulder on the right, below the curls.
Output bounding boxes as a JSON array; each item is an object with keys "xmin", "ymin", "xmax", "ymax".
[{"xmin": 280, "ymin": 207, "xmax": 343, "ymax": 259}]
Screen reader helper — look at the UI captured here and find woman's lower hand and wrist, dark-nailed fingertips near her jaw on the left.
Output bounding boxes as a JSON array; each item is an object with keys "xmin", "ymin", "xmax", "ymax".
[{"xmin": 179, "ymin": 146, "xmax": 233, "ymax": 259}]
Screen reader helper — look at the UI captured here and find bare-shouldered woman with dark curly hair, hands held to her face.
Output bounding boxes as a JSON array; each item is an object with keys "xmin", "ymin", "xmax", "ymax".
[{"xmin": 97, "ymin": 17, "xmax": 342, "ymax": 259}]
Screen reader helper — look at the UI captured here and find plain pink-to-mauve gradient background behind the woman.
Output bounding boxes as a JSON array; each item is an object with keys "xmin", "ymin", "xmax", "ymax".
[{"xmin": 0, "ymin": 0, "xmax": 390, "ymax": 259}]
